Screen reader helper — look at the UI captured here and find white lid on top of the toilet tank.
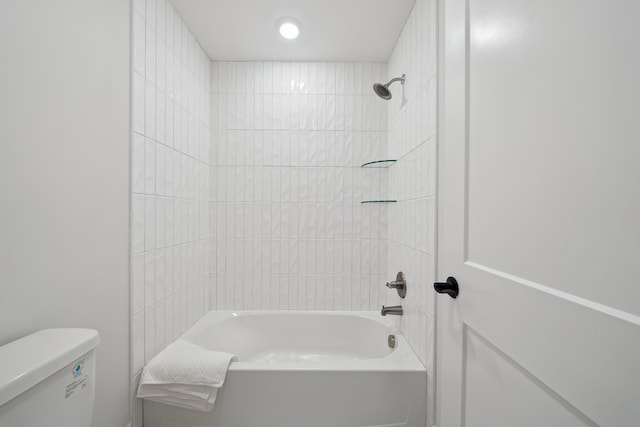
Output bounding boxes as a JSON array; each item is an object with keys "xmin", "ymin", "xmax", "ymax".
[{"xmin": 0, "ymin": 328, "xmax": 100, "ymax": 406}]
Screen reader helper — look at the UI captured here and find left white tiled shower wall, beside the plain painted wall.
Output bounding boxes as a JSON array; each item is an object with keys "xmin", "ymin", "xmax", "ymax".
[{"xmin": 131, "ymin": 0, "xmax": 210, "ymax": 426}]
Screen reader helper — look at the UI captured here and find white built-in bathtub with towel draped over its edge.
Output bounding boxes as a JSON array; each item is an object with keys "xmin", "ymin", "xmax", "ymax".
[{"xmin": 144, "ymin": 311, "xmax": 427, "ymax": 427}]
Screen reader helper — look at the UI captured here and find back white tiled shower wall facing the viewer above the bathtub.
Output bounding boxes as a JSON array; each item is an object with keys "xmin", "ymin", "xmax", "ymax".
[{"xmin": 209, "ymin": 62, "xmax": 388, "ymax": 310}]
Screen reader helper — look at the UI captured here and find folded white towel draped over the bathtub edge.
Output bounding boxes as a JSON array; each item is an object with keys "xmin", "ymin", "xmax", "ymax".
[{"xmin": 138, "ymin": 339, "xmax": 236, "ymax": 411}]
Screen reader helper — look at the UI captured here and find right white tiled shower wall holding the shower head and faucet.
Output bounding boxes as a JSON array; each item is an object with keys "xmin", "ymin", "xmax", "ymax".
[{"xmin": 386, "ymin": 0, "xmax": 437, "ymax": 426}]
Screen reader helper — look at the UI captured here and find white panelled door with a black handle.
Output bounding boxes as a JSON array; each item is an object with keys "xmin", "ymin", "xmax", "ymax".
[{"xmin": 436, "ymin": 0, "xmax": 640, "ymax": 427}]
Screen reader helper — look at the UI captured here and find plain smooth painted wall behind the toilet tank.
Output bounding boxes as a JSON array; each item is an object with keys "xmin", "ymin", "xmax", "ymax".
[{"xmin": 0, "ymin": 0, "xmax": 130, "ymax": 427}]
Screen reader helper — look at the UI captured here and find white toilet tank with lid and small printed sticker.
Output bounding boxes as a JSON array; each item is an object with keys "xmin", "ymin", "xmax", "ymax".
[{"xmin": 0, "ymin": 329, "xmax": 100, "ymax": 427}]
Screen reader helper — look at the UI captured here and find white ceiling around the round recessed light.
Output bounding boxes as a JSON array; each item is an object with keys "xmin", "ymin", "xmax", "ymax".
[{"xmin": 170, "ymin": 0, "xmax": 415, "ymax": 62}]
